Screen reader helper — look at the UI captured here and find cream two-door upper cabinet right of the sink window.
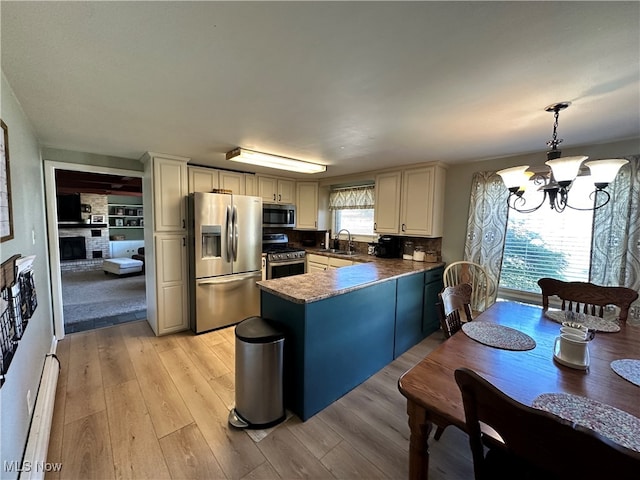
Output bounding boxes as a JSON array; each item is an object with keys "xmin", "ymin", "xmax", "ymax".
[{"xmin": 375, "ymin": 165, "xmax": 446, "ymax": 237}]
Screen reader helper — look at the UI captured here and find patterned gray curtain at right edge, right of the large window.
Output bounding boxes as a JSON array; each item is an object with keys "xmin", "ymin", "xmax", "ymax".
[{"xmin": 589, "ymin": 155, "xmax": 640, "ymax": 325}]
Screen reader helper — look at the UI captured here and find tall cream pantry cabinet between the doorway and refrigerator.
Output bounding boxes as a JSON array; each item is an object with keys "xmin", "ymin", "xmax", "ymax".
[{"xmin": 141, "ymin": 152, "xmax": 189, "ymax": 335}]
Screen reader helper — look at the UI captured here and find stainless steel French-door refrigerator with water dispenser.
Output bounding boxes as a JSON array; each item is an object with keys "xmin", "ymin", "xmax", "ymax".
[{"xmin": 189, "ymin": 193, "xmax": 262, "ymax": 333}]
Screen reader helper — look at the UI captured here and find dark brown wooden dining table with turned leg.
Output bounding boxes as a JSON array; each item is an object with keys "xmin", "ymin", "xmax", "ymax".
[{"xmin": 398, "ymin": 302, "xmax": 640, "ymax": 479}]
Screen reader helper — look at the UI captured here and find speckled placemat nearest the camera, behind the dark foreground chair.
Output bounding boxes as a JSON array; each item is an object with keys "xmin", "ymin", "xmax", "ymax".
[{"xmin": 531, "ymin": 393, "xmax": 640, "ymax": 452}]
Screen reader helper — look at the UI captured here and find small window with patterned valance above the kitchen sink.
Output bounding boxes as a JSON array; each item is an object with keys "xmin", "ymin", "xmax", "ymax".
[{"xmin": 329, "ymin": 185, "xmax": 375, "ymax": 235}]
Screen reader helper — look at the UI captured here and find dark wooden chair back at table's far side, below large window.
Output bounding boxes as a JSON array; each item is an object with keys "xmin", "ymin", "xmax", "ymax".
[{"xmin": 538, "ymin": 278, "xmax": 638, "ymax": 322}]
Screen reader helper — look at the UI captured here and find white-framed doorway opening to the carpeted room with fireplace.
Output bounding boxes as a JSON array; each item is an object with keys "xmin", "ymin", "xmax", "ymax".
[{"xmin": 45, "ymin": 161, "xmax": 146, "ymax": 339}]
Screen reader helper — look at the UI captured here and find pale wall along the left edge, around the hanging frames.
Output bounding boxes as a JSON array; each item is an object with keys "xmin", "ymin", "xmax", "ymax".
[{"xmin": 0, "ymin": 73, "xmax": 53, "ymax": 478}]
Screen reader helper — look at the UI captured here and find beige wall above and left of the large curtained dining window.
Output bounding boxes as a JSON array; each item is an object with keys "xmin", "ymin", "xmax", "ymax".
[{"xmin": 442, "ymin": 138, "xmax": 640, "ymax": 263}]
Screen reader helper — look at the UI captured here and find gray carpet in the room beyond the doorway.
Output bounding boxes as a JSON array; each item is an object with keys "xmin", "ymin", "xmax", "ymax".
[{"xmin": 62, "ymin": 270, "xmax": 147, "ymax": 324}]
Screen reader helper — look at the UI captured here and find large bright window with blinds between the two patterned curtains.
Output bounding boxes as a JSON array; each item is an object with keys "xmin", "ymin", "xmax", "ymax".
[{"xmin": 499, "ymin": 176, "xmax": 594, "ymax": 293}]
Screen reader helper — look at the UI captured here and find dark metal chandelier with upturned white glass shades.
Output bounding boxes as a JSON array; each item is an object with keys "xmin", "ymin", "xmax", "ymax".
[{"xmin": 497, "ymin": 102, "xmax": 629, "ymax": 213}]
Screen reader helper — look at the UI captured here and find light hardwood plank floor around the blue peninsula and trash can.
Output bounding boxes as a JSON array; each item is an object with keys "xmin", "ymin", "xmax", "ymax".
[{"xmin": 47, "ymin": 321, "xmax": 473, "ymax": 480}]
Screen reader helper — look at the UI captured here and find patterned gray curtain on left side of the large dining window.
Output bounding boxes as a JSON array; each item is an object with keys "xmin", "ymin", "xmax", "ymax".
[{"xmin": 464, "ymin": 172, "xmax": 509, "ymax": 304}]
